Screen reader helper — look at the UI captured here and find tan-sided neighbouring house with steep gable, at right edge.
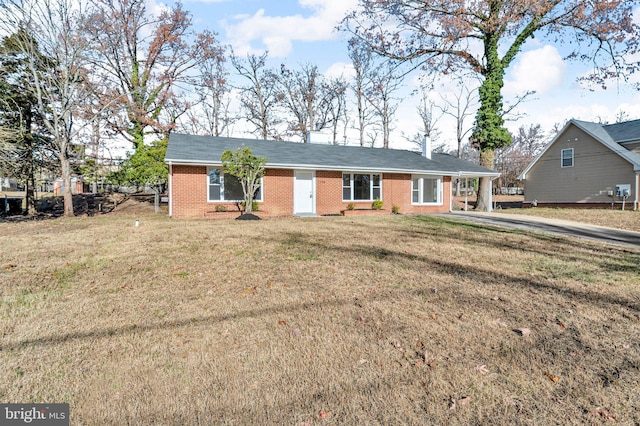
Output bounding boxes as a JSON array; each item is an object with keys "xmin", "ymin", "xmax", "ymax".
[{"xmin": 519, "ymin": 120, "xmax": 640, "ymax": 209}]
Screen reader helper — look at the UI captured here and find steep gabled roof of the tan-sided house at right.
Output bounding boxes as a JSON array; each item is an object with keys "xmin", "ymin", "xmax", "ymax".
[{"xmin": 518, "ymin": 120, "xmax": 640, "ymax": 180}]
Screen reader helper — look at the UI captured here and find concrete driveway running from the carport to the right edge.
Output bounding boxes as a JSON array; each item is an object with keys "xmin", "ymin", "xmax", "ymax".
[{"xmin": 442, "ymin": 211, "xmax": 640, "ymax": 248}]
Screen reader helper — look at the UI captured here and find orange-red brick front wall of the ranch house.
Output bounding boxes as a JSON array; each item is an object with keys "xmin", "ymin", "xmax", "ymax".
[{"xmin": 172, "ymin": 165, "xmax": 451, "ymax": 218}]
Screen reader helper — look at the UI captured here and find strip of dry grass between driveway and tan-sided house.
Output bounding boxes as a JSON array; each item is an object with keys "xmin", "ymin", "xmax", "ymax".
[{"xmin": 496, "ymin": 205, "xmax": 640, "ymax": 232}]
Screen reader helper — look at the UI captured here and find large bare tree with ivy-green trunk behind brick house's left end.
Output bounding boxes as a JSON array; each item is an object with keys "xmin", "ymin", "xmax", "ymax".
[{"xmin": 86, "ymin": 0, "xmax": 210, "ymax": 150}]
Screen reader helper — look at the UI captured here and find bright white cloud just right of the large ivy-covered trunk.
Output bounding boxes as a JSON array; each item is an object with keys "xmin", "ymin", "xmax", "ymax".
[{"xmin": 503, "ymin": 45, "xmax": 567, "ymax": 96}]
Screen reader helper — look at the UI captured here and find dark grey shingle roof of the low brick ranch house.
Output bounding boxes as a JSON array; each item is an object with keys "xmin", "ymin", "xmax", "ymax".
[{"xmin": 165, "ymin": 133, "xmax": 500, "ymax": 176}]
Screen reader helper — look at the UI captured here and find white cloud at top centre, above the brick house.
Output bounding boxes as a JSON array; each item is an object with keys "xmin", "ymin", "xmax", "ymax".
[{"xmin": 224, "ymin": 0, "xmax": 356, "ymax": 58}]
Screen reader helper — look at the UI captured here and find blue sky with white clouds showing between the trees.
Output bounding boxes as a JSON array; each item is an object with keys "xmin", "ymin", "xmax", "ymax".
[{"xmin": 157, "ymin": 0, "xmax": 640, "ymax": 148}]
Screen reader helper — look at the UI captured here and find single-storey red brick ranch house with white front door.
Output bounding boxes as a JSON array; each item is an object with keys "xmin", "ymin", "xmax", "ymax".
[{"xmin": 165, "ymin": 134, "xmax": 499, "ymax": 218}]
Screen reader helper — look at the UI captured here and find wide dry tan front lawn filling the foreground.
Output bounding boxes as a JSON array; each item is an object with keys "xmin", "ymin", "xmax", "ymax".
[{"xmin": 0, "ymin": 211, "xmax": 640, "ymax": 425}]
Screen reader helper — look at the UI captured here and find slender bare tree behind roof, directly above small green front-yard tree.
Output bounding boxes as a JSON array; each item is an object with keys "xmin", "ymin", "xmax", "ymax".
[{"xmin": 231, "ymin": 52, "xmax": 280, "ymax": 139}]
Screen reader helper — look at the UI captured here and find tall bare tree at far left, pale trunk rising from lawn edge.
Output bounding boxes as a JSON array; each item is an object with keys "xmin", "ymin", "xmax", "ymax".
[{"xmin": 0, "ymin": 0, "xmax": 108, "ymax": 216}]
